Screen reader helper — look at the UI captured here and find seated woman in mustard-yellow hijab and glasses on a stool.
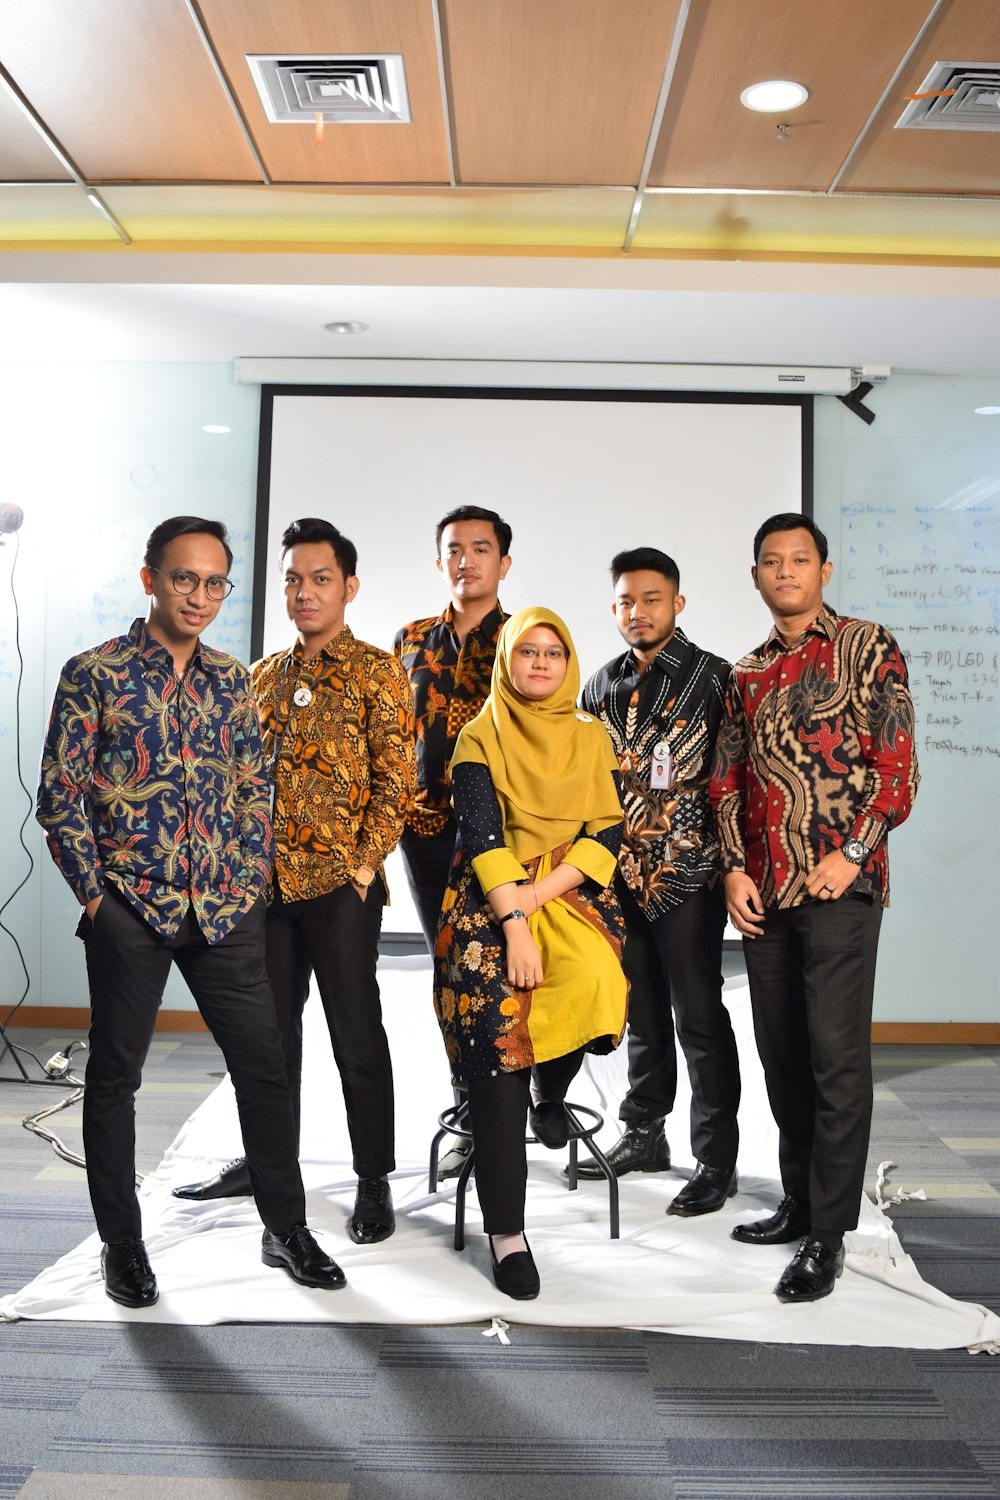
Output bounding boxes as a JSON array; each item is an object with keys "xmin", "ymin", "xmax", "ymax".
[{"xmin": 435, "ymin": 608, "xmax": 628, "ymax": 1299}]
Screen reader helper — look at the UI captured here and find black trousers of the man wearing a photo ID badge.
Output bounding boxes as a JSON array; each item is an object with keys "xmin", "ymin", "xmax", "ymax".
[{"xmin": 618, "ymin": 879, "xmax": 739, "ymax": 1169}]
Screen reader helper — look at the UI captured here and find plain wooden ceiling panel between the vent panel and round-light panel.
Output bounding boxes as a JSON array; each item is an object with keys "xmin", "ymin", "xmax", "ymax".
[{"xmin": 442, "ymin": 0, "xmax": 678, "ymax": 186}]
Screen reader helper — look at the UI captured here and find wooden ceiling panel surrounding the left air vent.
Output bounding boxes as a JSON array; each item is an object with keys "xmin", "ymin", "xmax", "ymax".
[{"xmin": 201, "ymin": 0, "xmax": 448, "ymax": 183}]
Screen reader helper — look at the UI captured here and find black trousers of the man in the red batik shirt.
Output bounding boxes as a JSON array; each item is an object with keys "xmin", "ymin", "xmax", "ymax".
[{"xmin": 744, "ymin": 896, "xmax": 882, "ymax": 1233}]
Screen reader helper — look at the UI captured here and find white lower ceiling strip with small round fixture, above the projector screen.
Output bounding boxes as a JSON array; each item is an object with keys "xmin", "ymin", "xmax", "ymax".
[{"xmin": 0, "ymin": 255, "xmax": 1000, "ymax": 377}]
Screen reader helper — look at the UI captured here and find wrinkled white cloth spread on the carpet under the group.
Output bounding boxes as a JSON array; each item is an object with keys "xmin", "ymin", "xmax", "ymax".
[{"xmin": 0, "ymin": 959, "xmax": 1000, "ymax": 1358}]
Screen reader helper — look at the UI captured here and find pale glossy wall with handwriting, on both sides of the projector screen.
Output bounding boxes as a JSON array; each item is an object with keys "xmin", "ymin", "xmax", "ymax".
[{"xmin": 0, "ymin": 363, "xmax": 1000, "ymax": 1022}]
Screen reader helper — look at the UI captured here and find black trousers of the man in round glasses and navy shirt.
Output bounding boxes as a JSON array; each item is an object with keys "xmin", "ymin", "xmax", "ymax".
[{"xmin": 79, "ymin": 888, "xmax": 306, "ymax": 1241}]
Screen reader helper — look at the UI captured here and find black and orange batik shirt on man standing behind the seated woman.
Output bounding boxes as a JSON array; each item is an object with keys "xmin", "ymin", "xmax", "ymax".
[{"xmin": 393, "ymin": 605, "xmax": 507, "ymax": 839}]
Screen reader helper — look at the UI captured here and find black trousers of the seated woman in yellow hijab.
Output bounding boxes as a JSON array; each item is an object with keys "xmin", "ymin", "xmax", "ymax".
[{"xmin": 468, "ymin": 1047, "xmax": 585, "ymax": 1235}]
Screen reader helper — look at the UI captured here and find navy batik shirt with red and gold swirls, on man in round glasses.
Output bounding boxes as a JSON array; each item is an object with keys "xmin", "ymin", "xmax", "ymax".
[{"xmin": 36, "ymin": 620, "xmax": 271, "ymax": 942}]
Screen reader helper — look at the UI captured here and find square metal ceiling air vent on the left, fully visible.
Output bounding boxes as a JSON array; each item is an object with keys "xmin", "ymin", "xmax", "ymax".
[{"xmin": 247, "ymin": 53, "xmax": 409, "ymax": 125}]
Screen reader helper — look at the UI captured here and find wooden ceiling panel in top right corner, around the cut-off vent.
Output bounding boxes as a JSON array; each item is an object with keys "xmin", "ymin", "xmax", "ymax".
[{"xmin": 840, "ymin": 0, "xmax": 1000, "ymax": 194}]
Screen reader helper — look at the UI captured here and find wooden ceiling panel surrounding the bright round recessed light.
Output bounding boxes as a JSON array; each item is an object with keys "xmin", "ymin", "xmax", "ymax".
[{"xmin": 649, "ymin": 0, "xmax": 935, "ymax": 191}]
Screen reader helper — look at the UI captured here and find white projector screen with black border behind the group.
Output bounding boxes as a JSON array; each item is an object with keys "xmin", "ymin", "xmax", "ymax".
[{"xmin": 253, "ymin": 386, "xmax": 813, "ymax": 933}]
